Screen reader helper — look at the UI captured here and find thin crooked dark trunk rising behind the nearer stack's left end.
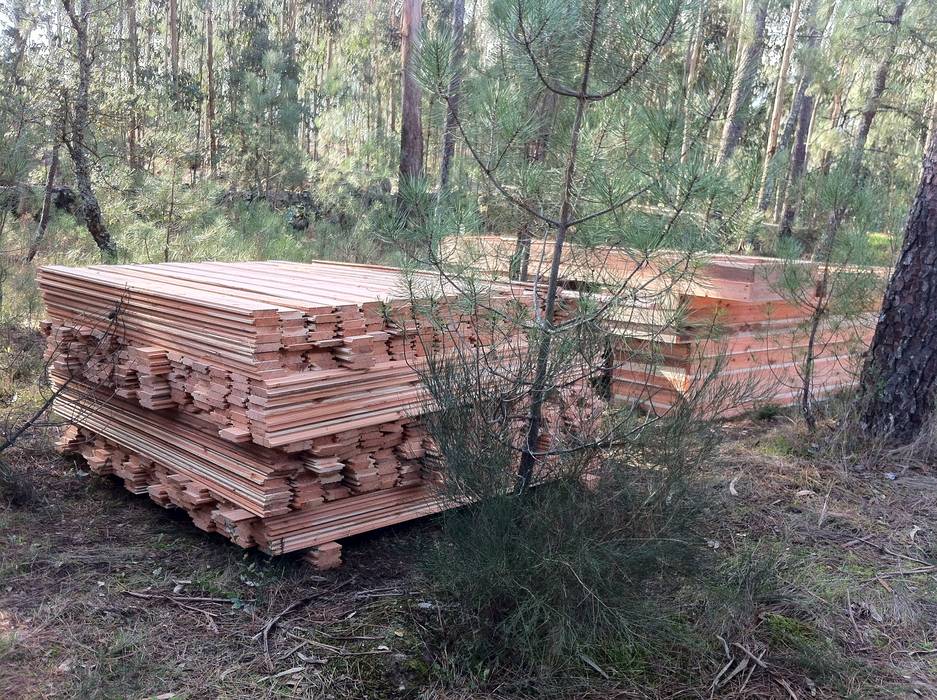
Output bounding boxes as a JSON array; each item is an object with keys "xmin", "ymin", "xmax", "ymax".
[{"xmin": 62, "ymin": 0, "xmax": 117, "ymax": 257}]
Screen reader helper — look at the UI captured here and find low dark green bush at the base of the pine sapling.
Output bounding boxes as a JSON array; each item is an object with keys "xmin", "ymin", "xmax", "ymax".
[{"xmin": 428, "ymin": 433, "xmax": 716, "ymax": 675}]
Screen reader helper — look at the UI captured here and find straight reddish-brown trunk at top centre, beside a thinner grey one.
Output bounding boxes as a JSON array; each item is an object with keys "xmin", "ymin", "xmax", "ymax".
[{"xmin": 400, "ymin": 0, "xmax": 423, "ymax": 185}]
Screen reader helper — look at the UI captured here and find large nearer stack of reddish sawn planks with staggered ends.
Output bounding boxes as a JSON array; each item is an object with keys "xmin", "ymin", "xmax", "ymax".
[{"xmin": 39, "ymin": 262, "xmax": 588, "ymax": 567}]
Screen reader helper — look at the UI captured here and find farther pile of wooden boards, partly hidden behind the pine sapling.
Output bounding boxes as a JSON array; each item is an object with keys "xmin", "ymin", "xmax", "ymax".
[{"xmin": 443, "ymin": 236, "xmax": 884, "ymax": 416}]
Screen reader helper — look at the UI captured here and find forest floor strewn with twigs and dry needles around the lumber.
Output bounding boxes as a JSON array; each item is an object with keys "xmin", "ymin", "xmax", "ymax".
[{"xmin": 0, "ymin": 330, "xmax": 937, "ymax": 699}]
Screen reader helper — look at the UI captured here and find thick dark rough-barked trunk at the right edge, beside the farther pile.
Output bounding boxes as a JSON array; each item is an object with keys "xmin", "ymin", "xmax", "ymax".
[{"xmin": 861, "ymin": 139, "xmax": 937, "ymax": 442}]
